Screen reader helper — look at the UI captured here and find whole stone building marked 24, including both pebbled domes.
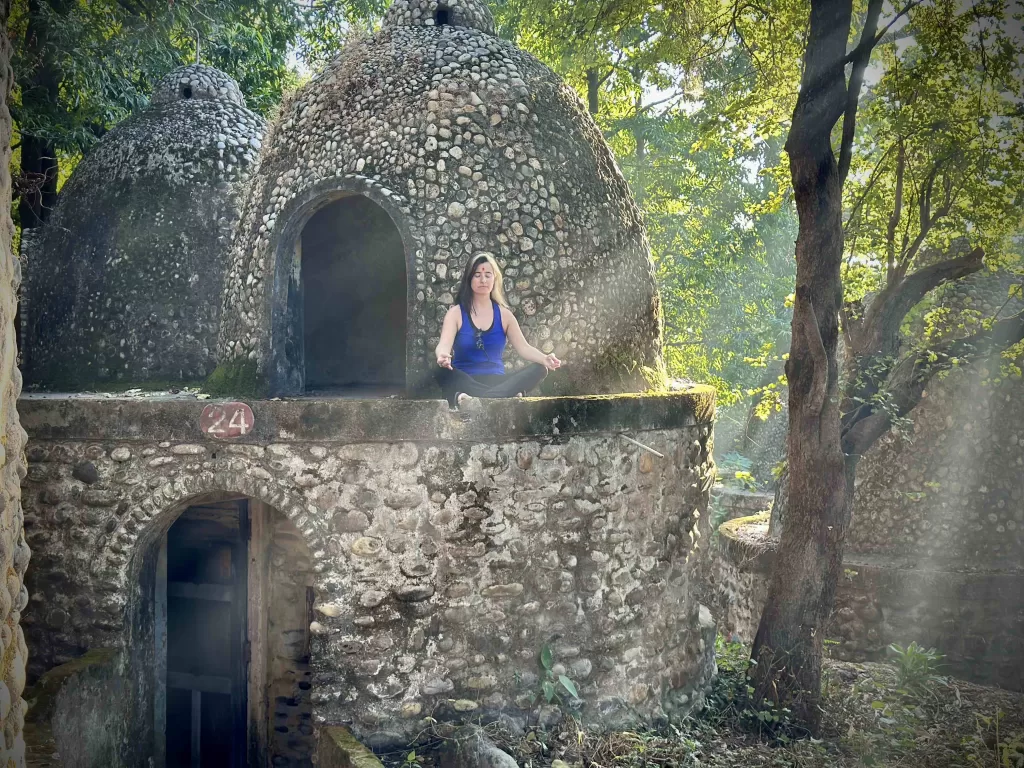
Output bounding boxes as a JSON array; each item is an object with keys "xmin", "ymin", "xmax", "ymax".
[{"xmin": 19, "ymin": 0, "xmax": 715, "ymax": 768}]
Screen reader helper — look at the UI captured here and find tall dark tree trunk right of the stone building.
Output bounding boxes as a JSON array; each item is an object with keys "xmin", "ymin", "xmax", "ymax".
[{"xmin": 752, "ymin": 0, "xmax": 853, "ymax": 729}]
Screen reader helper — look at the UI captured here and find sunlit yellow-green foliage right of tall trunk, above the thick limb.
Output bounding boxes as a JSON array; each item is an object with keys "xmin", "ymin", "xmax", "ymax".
[{"xmin": 845, "ymin": 0, "xmax": 1024, "ymax": 300}]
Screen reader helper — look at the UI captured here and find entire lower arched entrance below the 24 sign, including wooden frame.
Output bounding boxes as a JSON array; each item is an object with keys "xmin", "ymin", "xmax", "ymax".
[{"xmin": 143, "ymin": 494, "xmax": 314, "ymax": 768}]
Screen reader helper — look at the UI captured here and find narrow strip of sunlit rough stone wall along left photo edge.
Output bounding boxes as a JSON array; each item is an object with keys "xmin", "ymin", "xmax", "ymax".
[{"xmin": 0, "ymin": 0, "xmax": 30, "ymax": 767}]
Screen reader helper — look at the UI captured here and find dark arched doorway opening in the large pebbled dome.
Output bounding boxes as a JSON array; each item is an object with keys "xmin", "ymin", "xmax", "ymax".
[{"xmin": 300, "ymin": 195, "xmax": 408, "ymax": 396}]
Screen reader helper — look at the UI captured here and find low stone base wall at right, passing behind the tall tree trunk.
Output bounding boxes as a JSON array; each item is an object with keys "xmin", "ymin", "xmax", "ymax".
[{"xmin": 707, "ymin": 514, "xmax": 1024, "ymax": 690}]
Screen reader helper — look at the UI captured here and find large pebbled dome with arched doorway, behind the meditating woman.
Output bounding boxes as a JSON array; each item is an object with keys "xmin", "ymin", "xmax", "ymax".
[{"xmin": 219, "ymin": 0, "xmax": 660, "ymax": 394}]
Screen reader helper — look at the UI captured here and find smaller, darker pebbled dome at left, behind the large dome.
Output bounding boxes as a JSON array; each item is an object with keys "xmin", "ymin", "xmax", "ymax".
[{"xmin": 23, "ymin": 65, "xmax": 265, "ymax": 391}]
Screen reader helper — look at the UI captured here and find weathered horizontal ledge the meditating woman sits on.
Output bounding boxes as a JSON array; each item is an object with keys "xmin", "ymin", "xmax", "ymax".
[{"xmin": 17, "ymin": 386, "xmax": 715, "ymax": 443}]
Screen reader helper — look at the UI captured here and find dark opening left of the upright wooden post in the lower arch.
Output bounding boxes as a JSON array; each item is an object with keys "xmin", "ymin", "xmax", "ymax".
[{"xmin": 157, "ymin": 500, "xmax": 249, "ymax": 768}]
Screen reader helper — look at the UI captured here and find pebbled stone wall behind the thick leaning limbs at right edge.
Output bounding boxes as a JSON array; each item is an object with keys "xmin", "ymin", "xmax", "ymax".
[{"xmin": 847, "ymin": 357, "xmax": 1024, "ymax": 568}]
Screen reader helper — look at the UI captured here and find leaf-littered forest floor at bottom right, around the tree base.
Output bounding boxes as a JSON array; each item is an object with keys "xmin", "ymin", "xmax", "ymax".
[{"xmin": 382, "ymin": 645, "xmax": 1024, "ymax": 768}]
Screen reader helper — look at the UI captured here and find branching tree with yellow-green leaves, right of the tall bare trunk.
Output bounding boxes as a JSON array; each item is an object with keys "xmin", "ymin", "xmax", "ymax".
[{"xmin": 842, "ymin": 0, "xmax": 1024, "ymax": 460}]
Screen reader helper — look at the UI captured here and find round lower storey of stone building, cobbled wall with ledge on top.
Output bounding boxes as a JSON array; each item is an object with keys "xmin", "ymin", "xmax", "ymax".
[{"xmin": 22, "ymin": 388, "xmax": 715, "ymax": 766}]
